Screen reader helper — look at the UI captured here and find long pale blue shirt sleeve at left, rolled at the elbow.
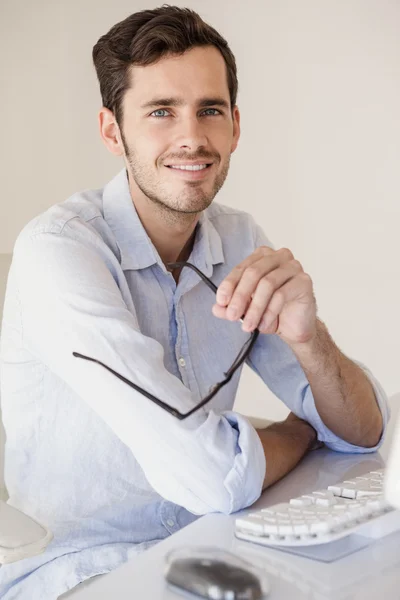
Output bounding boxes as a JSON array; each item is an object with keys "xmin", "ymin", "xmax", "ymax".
[{"xmin": 12, "ymin": 224, "xmax": 265, "ymax": 515}]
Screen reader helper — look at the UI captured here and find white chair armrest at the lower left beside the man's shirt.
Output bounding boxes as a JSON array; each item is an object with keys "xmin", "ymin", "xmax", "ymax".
[{"xmin": 0, "ymin": 501, "xmax": 53, "ymax": 564}]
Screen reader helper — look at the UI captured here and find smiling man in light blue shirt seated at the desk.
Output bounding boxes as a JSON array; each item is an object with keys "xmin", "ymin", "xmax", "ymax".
[{"xmin": 0, "ymin": 6, "xmax": 388, "ymax": 600}]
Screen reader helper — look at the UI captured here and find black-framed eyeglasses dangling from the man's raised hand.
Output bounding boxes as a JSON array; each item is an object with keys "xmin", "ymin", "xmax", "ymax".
[{"xmin": 72, "ymin": 262, "xmax": 260, "ymax": 421}]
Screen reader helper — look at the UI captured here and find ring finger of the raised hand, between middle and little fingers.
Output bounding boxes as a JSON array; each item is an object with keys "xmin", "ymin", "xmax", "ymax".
[{"xmin": 242, "ymin": 260, "xmax": 303, "ymax": 332}]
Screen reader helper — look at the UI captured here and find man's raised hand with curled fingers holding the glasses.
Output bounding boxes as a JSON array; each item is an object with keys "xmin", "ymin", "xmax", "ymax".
[{"xmin": 213, "ymin": 246, "xmax": 317, "ymax": 344}]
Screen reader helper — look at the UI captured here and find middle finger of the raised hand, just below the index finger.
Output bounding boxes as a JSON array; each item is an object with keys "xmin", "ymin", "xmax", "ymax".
[{"xmin": 227, "ymin": 249, "xmax": 293, "ymax": 321}]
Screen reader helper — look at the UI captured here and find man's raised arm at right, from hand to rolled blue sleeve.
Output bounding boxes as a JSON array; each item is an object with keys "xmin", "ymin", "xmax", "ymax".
[{"xmin": 213, "ymin": 224, "xmax": 390, "ymax": 452}]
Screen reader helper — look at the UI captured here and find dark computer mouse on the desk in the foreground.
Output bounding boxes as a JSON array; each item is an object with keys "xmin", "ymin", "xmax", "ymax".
[{"xmin": 165, "ymin": 556, "xmax": 265, "ymax": 600}]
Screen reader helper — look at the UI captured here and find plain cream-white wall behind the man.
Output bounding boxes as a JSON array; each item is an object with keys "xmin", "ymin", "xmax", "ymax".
[{"xmin": 0, "ymin": 0, "xmax": 400, "ymax": 418}]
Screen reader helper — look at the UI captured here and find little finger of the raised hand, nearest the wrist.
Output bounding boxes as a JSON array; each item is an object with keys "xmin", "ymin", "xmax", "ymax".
[{"xmin": 259, "ymin": 273, "xmax": 314, "ymax": 333}]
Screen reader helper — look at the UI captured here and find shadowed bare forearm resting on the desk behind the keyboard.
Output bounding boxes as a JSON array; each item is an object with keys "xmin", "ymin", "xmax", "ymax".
[{"xmin": 257, "ymin": 414, "xmax": 316, "ymax": 490}]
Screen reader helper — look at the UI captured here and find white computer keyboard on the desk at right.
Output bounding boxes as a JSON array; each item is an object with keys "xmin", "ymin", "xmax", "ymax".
[{"xmin": 235, "ymin": 469, "xmax": 400, "ymax": 546}]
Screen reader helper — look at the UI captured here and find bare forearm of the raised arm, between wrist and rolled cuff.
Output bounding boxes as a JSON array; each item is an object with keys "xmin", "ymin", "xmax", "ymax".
[{"xmin": 291, "ymin": 320, "xmax": 383, "ymax": 448}]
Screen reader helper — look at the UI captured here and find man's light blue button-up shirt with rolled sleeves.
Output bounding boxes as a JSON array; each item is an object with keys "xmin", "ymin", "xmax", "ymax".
[{"xmin": 0, "ymin": 170, "xmax": 388, "ymax": 600}]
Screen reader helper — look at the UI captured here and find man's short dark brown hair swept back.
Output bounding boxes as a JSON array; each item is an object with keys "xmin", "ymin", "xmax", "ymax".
[{"xmin": 92, "ymin": 4, "xmax": 238, "ymax": 126}]
